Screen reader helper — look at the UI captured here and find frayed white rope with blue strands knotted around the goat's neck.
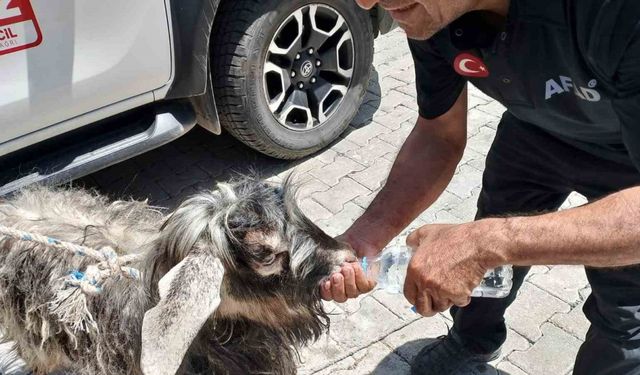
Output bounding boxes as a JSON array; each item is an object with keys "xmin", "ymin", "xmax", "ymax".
[{"xmin": 0, "ymin": 225, "xmax": 143, "ymax": 332}]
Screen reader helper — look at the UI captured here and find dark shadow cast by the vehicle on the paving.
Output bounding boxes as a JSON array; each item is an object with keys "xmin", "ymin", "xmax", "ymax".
[{"xmin": 78, "ymin": 70, "xmax": 381, "ymax": 208}]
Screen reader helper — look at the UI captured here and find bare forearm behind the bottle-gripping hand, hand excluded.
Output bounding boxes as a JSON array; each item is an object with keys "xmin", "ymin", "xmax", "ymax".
[{"xmin": 484, "ymin": 187, "xmax": 640, "ymax": 267}]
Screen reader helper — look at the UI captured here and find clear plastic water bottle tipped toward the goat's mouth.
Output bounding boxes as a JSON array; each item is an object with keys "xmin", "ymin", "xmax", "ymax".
[{"xmin": 360, "ymin": 245, "xmax": 513, "ymax": 298}]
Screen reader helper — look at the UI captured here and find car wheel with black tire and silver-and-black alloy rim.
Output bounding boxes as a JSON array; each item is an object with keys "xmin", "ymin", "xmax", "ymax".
[{"xmin": 211, "ymin": 0, "xmax": 374, "ymax": 159}]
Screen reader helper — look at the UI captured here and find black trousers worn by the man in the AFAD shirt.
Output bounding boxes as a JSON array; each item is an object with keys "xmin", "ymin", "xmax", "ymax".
[{"xmin": 451, "ymin": 112, "xmax": 640, "ymax": 375}]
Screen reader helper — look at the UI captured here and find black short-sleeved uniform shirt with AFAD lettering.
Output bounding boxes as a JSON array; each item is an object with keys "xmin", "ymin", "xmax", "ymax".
[{"xmin": 409, "ymin": 0, "xmax": 640, "ymax": 169}]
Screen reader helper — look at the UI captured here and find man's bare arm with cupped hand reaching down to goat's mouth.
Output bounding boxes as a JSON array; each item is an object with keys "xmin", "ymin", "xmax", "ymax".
[{"xmin": 321, "ymin": 89, "xmax": 467, "ymax": 302}]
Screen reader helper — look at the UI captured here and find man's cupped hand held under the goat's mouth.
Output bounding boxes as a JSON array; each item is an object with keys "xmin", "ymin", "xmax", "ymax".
[{"xmin": 320, "ymin": 233, "xmax": 380, "ymax": 303}]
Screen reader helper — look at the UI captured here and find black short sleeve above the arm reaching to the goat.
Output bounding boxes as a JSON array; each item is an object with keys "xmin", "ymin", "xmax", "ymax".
[{"xmin": 409, "ymin": 29, "xmax": 466, "ymax": 119}]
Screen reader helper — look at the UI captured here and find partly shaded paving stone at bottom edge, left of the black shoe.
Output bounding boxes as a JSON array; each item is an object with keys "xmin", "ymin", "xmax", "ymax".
[{"xmin": 317, "ymin": 343, "xmax": 410, "ymax": 375}]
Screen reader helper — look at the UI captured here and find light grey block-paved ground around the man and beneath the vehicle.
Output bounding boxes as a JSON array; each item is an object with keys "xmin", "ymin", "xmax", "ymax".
[{"xmin": 79, "ymin": 31, "xmax": 589, "ymax": 375}]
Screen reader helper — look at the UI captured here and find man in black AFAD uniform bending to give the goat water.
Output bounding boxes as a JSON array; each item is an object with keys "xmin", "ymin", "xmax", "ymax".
[{"xmin": 321, "ymin": 0, "xmax": 640, "ymax": 375}]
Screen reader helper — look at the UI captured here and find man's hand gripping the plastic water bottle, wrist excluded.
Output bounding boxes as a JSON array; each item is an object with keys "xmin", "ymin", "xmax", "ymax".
[{"xmin": 404, "ymin": 222, "xmax": 499, "ymax": 316}]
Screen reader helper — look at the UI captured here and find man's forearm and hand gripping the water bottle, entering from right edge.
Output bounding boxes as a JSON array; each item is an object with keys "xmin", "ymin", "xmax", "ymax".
[{"xmin": 405, "ymin": 187, "xmax": 640, "ymax": 316}]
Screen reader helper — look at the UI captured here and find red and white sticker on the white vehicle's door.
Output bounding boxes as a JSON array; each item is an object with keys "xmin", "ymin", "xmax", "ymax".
[{"xmin": 0, "ymin": 0, "xmax": 42, "ymax": 56}]
